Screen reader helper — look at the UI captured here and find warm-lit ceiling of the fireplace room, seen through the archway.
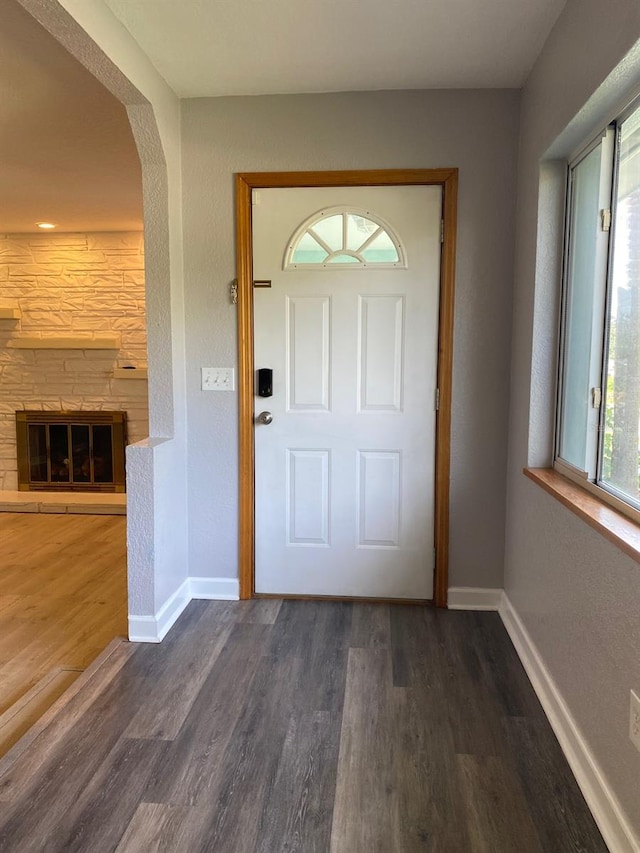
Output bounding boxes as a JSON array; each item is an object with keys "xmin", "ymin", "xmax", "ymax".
[{"xmin": 0, "ymin": 0, "xmax": 142, "ymax": 233}]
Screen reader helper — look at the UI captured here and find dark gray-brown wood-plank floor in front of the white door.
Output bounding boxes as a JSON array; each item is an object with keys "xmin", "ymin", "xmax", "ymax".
[{"xmin": 0, "ymin": 600, "xmax": 606, "ymax": 853}]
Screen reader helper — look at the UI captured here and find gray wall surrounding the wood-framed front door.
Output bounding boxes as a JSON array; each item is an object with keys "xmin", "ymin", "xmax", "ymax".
[{"xmin": 182, "ymin": 90, "xmax": 519, "ymax": 587}]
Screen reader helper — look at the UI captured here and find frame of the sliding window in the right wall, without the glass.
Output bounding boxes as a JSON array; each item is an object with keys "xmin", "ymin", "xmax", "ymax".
[{"xmin": 553, "ymin": 115, "xmax": 640, "ymax": 524}]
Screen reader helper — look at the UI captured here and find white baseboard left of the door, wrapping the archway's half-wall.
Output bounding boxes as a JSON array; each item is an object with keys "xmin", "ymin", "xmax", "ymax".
[{"xmin": 129, "ymin": 578, "xmax": 239, "ymax": 643}]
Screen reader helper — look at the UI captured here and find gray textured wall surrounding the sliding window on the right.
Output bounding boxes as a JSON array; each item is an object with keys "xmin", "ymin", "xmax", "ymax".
[{"xmin": 505, "ymin": 0, "xmax": 640, "ymax": 832}]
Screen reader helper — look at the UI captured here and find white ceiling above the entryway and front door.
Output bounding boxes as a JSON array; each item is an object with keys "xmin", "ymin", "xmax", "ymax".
[{"xmin": 104, "ymin": 0, "xmax": 565, "ymax": 97}]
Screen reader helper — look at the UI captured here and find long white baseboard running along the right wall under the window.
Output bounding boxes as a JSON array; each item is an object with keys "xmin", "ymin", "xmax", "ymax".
[{"xmin": 499, "ymin": 593, "xmax": 640, "ymax": 853}]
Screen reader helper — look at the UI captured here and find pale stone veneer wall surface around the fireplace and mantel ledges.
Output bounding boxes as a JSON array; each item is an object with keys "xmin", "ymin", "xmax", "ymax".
[{"xmin": 0, "ymin": 232, "xmax": 149, "ymax": 490}]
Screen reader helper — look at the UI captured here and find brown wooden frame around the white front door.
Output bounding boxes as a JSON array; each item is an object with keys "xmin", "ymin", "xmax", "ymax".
[{"xmin": 236, "ymin": 169, "xmax": 458, "ymax": 607}]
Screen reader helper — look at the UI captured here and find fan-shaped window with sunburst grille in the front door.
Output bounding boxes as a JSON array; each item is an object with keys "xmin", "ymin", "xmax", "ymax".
[{"xmin": 284, "ymin": 207, "xmax": 407, "ymax": 270}]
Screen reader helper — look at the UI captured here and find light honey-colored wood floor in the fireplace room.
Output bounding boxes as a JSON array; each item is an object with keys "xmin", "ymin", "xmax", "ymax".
[{"xmin": 0, "ymin": 513, "xmax": 127, "ymax": 754}]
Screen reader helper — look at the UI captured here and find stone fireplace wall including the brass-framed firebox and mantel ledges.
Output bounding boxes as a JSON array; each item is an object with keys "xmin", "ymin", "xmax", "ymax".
[{"xmin": 0, "ymin": 232, "xmax": 148, "ymax": 492}]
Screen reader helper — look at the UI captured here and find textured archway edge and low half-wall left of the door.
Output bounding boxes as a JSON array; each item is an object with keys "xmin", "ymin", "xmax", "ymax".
[{"xmin": 18, "ymin": 0, "xmax": 188, "ymax": 642}]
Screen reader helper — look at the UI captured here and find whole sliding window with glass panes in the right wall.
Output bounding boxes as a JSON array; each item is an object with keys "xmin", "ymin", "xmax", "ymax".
[{"xmin": 555, "ymin": 109, "xmax": 640, "ymax": 520}]
